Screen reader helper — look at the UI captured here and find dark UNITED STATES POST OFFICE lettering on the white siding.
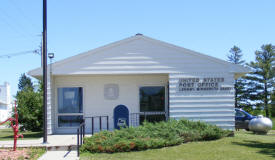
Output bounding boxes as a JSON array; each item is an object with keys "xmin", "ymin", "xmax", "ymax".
[{"xmin": 178, "ymin": 77, "xmax": 233, "ymax": 92}]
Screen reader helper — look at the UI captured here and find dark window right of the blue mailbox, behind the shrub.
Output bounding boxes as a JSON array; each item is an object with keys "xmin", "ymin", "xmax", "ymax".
[{"xmin": 139, "ymin": 86, "xmax": 165, "ymax": 124}]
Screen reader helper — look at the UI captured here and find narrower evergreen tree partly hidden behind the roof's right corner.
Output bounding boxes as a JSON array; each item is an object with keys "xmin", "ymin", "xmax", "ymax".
[{"xmin": 227, "ymin": 46, "xmax": 247, "ymax": 108}]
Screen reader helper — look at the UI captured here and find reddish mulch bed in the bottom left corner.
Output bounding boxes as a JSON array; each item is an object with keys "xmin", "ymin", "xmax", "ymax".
[{"xmin": 0, "ymin": 149, "xmax": 30, "ymax": 160}]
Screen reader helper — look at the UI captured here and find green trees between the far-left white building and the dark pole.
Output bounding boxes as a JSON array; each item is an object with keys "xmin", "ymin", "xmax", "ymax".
[{"xmin": 16, "ymin": 74, "xmax": 43, "ymax": 131}]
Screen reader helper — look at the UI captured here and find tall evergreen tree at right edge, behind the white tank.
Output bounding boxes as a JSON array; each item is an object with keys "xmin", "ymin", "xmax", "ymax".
[{"xmin": 245, "ymin": 44, "xmax": 275, "ymax": 117}]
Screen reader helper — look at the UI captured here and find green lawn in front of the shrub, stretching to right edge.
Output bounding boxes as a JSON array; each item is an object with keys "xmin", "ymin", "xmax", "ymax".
[{"xmin": 80, "ymin": 130, "xmax": 275, "ymax": 160}]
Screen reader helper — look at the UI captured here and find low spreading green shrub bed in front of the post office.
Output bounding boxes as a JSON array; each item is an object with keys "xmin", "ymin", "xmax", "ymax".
[{"xmin": 81, "ymin": 119, "xmax": 231, "ymax": 153}]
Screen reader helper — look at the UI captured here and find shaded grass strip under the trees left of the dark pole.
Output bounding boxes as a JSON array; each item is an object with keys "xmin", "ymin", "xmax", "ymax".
[{"xmin": 0, "ymin": 128, "xmax": 43, "ymax": 141}]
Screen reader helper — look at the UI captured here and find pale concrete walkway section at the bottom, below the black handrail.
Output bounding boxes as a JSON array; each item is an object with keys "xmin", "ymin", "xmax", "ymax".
[{"xmin": 38, "ymin": 151, "xmax": 79, "ymax": 160}]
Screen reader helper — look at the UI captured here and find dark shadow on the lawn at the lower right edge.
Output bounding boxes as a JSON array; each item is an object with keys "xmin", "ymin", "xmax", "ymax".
[{"xmin": 232, "ymin": 141, "xmax": 275, "ymax": 157}]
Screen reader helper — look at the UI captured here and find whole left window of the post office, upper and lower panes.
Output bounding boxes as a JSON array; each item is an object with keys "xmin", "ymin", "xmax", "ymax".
[{"xmin": 58, "ymin": 87, "xmax": 83, "ymax": 127}]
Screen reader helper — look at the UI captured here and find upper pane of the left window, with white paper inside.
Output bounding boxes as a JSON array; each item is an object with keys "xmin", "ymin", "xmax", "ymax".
[{"xmin": 58, "ymin": 87, "xmax": 83, "ymax": 113}]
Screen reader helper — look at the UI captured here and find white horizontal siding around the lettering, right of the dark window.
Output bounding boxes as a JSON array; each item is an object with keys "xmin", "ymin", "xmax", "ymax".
[{"xmin": 169, "ymin": 73, "xmax": 235, "ymax": 130}]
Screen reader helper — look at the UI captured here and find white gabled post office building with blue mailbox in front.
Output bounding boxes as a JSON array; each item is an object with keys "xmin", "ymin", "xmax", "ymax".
[{"xmin": 28, "ymin": 34, "xmax": 249, "ymax": 134}]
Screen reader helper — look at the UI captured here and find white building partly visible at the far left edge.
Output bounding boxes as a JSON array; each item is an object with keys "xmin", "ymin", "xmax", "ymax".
[{"xmin": 0, "ymin": 82, "xmax": 12, "ymax": 122}]
